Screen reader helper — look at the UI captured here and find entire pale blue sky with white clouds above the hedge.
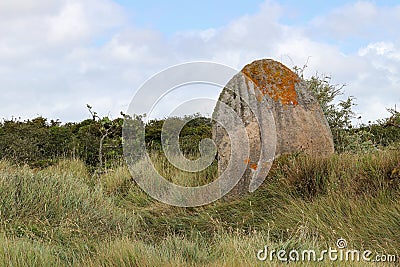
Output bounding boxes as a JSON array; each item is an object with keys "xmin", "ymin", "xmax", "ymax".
[{"xmin": 0, "ymin": 0, "xmax": 400, "ymax": 122}]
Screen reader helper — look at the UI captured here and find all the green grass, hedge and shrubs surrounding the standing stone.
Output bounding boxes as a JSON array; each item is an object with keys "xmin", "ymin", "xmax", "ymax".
[{"xmin": 0, "ymin": 76, "xmax": 400, "ymax": 266}]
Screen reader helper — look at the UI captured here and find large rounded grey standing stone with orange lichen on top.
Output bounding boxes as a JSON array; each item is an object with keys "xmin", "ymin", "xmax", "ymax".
[{"xmin": 213, "ymin": 59, "xmax": 334, "ymax": 195}]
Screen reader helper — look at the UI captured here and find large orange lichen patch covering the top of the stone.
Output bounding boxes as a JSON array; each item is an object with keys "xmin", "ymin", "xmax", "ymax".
[{"xmin": 242, "ymin": 60, "xmax": 300, "ymax": 105}]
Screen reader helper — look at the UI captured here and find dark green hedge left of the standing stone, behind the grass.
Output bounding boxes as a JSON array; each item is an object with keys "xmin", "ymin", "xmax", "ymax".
[{"xmin": 0, "ymin": 111, "xmax": 211, "ymax": 171}]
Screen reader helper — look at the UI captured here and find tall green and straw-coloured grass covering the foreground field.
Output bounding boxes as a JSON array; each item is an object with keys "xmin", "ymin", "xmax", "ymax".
[{"xmin": 0, "ymin": 150, "xmax": 400, "ymax": 266}]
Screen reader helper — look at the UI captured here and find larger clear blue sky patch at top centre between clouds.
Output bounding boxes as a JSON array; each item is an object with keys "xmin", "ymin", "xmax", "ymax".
[{"xmin": 116, "ymin": 0, "xmax": 263, "ymax": 35}]
